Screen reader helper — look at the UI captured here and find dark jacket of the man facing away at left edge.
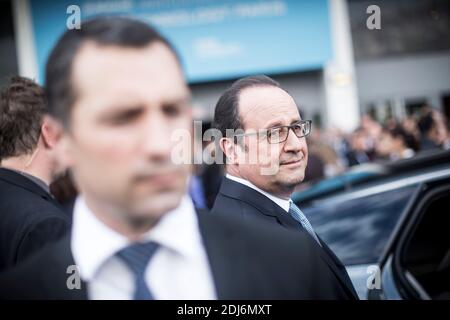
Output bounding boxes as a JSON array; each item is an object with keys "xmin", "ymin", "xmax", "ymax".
[{"xmin": 0, "ymin": 168, "xmax": 70, "ymax": 271}]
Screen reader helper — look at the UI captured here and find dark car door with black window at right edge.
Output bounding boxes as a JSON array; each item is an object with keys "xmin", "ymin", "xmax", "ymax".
[{"xmin": 369, "ymin": 178, "xmax": 450, "ymax": 300}]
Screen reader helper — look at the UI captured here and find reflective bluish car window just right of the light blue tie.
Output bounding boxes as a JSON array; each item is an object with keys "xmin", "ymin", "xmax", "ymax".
[{"xmin": 298, "ymin": 185, "xmax": 417, "ymax": 265}]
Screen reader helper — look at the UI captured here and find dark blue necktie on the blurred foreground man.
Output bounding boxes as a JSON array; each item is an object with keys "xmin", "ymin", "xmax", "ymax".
[{"xmin": 117, "ymin": 242, "xmax": 159, "ymax": 300}]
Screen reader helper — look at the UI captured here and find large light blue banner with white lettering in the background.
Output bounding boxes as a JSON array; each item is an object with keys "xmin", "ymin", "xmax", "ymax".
[{"xmin": 30, "ymin": 0, "xmax": 331, "ymax": 83}]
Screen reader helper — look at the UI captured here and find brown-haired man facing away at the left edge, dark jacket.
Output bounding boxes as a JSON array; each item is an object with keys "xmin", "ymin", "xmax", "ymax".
[{"xmin": 0, "ymin": 76, "xmax": 69, "ymax": 270}]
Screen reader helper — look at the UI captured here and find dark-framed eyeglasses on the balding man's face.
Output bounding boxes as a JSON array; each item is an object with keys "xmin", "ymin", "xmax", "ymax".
[{"xmin": 234, "ymin": 120, "xmax": 312, "ymax": 144}]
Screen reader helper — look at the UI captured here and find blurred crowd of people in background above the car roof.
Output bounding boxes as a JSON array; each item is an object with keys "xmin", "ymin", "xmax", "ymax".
[{"xmin": 306, "ymin": 105, "xmax": 450, "ymax": 182}]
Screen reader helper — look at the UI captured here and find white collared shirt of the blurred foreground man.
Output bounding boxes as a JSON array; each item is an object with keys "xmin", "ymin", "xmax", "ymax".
[{"xmin": 71, "ymin": 196, "xmax": 217, "ymax": 300}]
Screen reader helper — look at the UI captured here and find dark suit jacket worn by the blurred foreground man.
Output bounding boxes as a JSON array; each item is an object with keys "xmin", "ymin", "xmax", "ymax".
[{"xmin": 0, "ymin": 212, "xmax": 348, "ymax": 299}]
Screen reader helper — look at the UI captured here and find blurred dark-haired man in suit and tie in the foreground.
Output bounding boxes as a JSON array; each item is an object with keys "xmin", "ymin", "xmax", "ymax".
[{"xmin": 0, "ymin": 17, "xmax": 348, "ymax": 299}]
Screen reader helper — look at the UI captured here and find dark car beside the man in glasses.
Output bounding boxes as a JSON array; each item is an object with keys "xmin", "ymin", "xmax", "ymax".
[{"xmin": 293, "ymin": 151, "xmax": 450, "ymax": 299}]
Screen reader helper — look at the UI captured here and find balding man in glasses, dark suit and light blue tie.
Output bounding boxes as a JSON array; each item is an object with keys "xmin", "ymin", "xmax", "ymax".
[{"xmin": 211, "ymin": 76, "xmax": 356, "ymax": 298}]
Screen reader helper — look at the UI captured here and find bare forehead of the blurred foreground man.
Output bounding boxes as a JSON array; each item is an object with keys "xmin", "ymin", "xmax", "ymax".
[{"xmin": 72, "ymin": 41, "xmax": 186, "ymax": 97}]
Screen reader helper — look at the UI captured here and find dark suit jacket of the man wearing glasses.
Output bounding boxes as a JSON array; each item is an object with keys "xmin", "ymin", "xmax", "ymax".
[{"xmin": 211, "ymin": 178, "xmax": 357, "ymax": 299}]
